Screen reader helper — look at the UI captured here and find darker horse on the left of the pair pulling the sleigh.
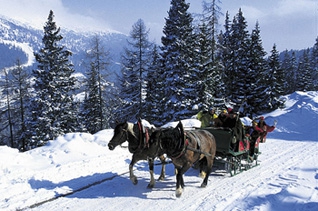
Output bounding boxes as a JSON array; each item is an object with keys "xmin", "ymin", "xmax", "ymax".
[{"xmin": 108, "ymin": 120, "xmax": 165, "ymax": 188}]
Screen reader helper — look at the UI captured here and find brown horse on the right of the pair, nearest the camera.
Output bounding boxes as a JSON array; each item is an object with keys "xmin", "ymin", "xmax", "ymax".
[{"xmin": 150, "ymin": 122, "xmax": 216, "ymax": 197}]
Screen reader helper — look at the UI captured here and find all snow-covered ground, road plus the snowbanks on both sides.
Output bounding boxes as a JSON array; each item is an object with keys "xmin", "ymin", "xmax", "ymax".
[{"xmin": 0, "ymin": 92, "xmax": 318, "ymax": 211}]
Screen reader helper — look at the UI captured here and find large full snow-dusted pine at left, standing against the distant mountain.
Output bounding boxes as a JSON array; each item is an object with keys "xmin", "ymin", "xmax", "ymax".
[{"xmin": 27, "ymin": 10, "xmax": 77, "ymax": 147}]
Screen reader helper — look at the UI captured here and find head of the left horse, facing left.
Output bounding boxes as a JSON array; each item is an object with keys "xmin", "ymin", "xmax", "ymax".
[{"xmin": 108, "ymin": 122, "xmax": 134, "ymax": 150}]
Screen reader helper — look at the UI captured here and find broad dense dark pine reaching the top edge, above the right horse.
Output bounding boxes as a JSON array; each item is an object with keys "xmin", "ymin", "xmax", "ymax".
[{"xmin": 158, "ymin": 0, "xmax": 199, "ymax": 123}]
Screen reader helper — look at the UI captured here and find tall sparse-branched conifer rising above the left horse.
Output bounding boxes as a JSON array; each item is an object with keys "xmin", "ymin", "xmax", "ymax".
[{"xmin": 116, "ymin": 19, "xmax": 153, "ymax": 121}]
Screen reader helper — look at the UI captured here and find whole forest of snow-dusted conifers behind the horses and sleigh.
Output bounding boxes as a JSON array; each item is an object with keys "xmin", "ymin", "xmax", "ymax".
[{"xmin": 0, "ymin": 0, "xmax": 318, "ymax": 151}]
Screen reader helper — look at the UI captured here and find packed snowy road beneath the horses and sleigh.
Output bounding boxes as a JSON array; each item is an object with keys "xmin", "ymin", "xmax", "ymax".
[{"xmin": 27, "ymin": 139, "xmax": 318, "ymax": 210}]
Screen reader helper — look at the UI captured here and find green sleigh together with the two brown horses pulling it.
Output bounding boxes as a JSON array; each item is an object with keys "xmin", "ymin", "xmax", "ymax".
[{"xmin": 108, "ymin": 116, "xmax": 260, "ymax": 197}]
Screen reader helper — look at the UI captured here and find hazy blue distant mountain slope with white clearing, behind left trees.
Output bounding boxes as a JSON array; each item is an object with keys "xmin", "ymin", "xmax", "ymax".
[{"xmin": 0, "ymin": 16, "xmax": 128, "ymax": 81}]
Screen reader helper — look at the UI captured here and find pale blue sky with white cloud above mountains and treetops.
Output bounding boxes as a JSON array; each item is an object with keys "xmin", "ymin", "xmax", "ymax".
[{"xmin": 0, "ymin": 0, "xmax": 318, "ymax": 52}]
